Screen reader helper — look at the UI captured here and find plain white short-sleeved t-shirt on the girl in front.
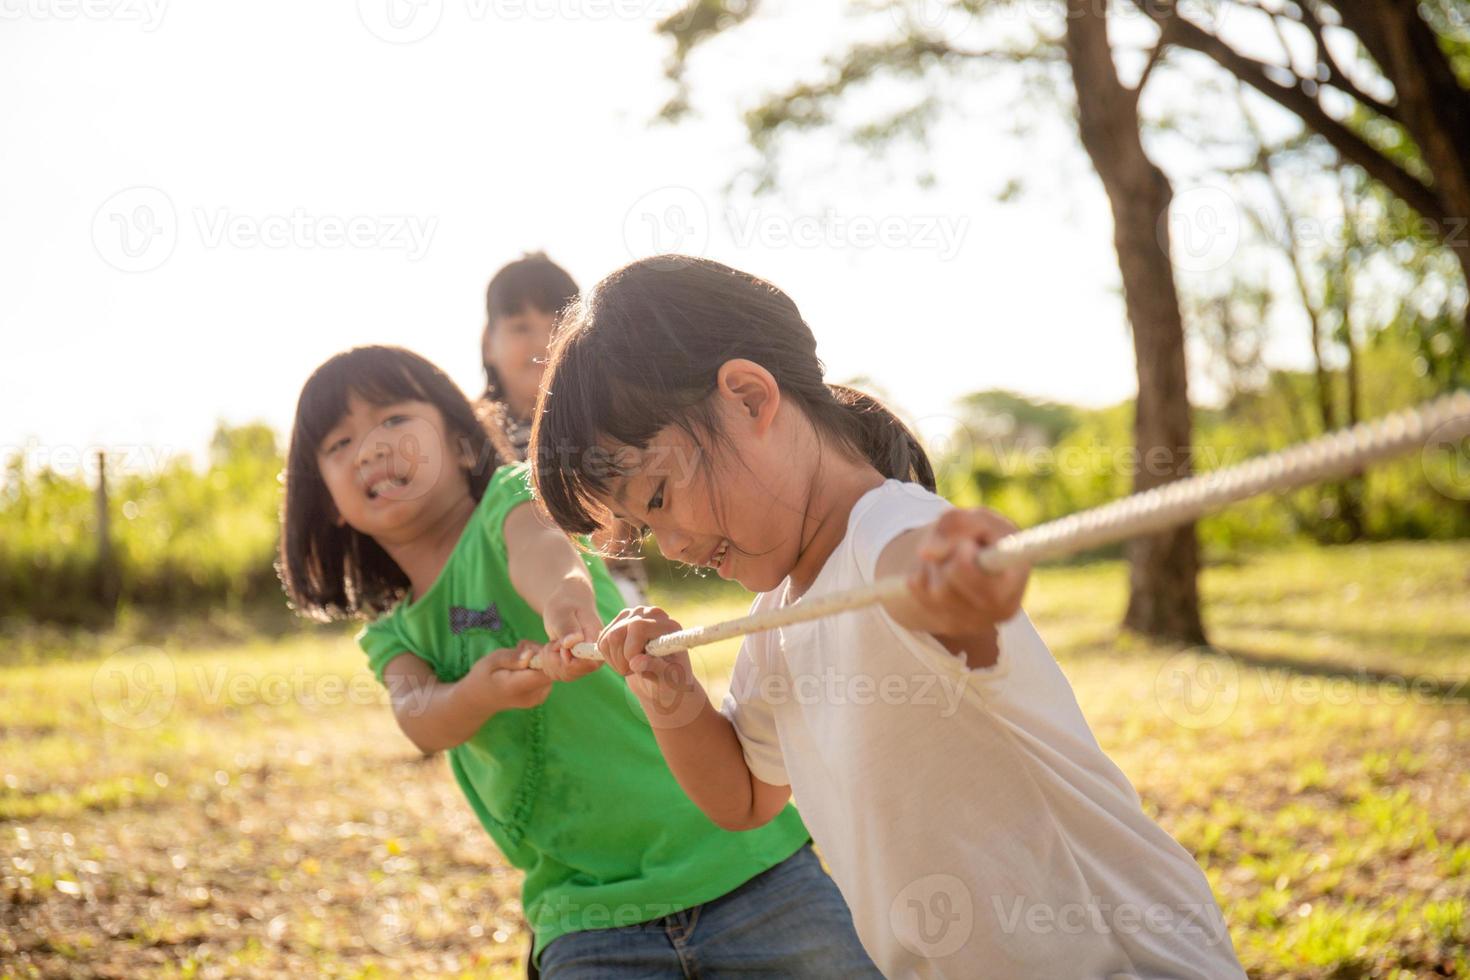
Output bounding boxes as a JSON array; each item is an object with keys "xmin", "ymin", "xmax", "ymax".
[{"xmin": 722, "ymin": 479, "xmax": 1245, "ymax": 980}]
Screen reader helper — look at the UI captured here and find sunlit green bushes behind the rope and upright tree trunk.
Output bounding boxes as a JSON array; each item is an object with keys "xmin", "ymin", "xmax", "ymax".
[{"xmin": 938, "ymin": 334, "xmax": 1470, "ymax": 557}]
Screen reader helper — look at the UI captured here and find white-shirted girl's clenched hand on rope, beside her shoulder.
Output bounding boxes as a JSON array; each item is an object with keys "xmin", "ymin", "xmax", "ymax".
[{"xmin": 908, "ymin": 507, "xmax": 1030, "ymax": 636}]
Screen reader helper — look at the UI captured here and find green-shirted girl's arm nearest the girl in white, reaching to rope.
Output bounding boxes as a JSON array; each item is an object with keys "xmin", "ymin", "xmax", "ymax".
[{"xmin": 504, "ymin": 501, "xmax": 603, "ymax": 680}]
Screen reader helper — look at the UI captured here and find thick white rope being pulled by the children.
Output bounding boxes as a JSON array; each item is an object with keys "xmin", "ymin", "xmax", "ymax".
[{"xmin": 531, "ymin": 391, "xmax": 1470, "ymax": 667}]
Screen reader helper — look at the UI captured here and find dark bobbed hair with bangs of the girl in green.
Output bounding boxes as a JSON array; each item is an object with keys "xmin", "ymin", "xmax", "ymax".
[{"xmin": 276, "ymin": 347, "xmax": 513, "ymax": 620}]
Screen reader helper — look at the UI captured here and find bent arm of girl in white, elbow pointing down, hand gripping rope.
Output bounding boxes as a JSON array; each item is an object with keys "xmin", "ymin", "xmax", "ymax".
[{"xmin": 597, "ymin": 605, "xmax": 791, "ymax": 830}]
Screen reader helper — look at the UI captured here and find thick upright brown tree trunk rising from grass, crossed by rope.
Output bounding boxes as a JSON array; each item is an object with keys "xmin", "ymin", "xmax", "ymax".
[{"xmin": 1066, "ymin": 0, "xmax": 1204, "ymax": 644}]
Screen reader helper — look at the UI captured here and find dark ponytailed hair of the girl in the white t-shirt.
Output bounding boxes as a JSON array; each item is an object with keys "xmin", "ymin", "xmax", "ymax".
[{"xmin": 529, "ymin": 256, "xmax": 935, "ymax": 533}]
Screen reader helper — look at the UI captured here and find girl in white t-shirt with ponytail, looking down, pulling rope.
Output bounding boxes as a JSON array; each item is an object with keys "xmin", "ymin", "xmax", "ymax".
[{"xmin": 531, "ymin": 256, "xmax": 1244, "ymax": 980}]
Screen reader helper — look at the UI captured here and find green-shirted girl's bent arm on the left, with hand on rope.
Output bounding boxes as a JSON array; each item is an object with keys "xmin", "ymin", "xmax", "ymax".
[{"xmin": 382, "ymin": 641, "xmax": 551, "ymax": 754}]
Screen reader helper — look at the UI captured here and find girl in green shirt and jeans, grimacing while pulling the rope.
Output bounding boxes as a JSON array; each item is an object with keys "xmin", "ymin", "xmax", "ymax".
[{"xmin": 281, "ymin": 340, "xmax": 878, "ymax": 980}]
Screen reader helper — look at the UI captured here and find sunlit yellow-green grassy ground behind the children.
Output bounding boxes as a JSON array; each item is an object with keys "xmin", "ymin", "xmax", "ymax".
[{"xmin": 0, "ymin": 544, "xmax": 1470, "ymax": 977}]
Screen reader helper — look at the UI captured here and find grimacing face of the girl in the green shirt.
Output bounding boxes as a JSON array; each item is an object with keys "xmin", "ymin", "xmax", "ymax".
[{"xmin": 316, "ymin": 392, "xmax": 469, "ymax": 539}]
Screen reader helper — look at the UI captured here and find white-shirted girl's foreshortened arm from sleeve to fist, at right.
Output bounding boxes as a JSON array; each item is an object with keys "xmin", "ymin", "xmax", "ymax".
[{"xmin": 875, "ymin": 507, "xmax": 1030, "ymax": 667}]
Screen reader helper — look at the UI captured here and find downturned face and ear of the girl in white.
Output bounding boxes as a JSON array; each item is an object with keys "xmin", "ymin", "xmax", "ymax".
[{"xmin": 590, "ymin": 359, "xmax": 811, "ymax": 592}]
